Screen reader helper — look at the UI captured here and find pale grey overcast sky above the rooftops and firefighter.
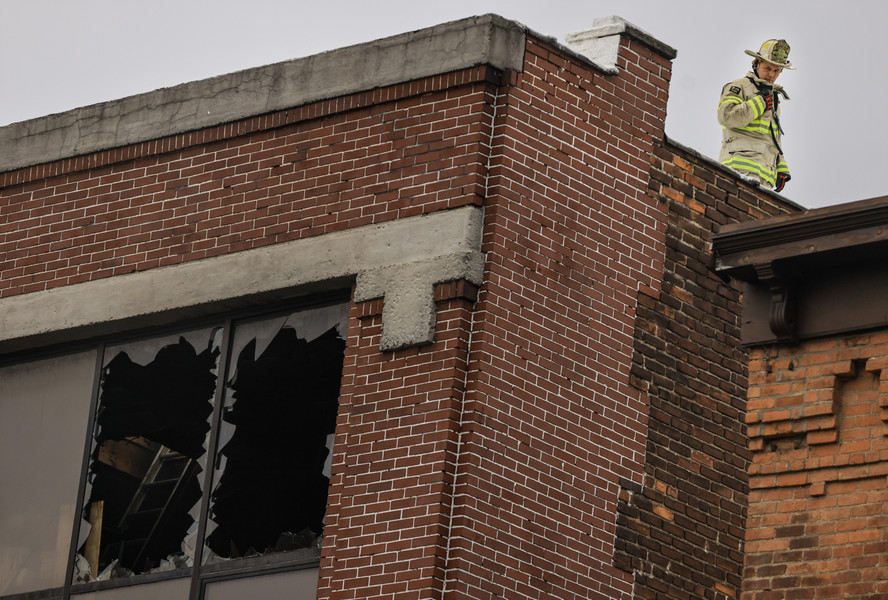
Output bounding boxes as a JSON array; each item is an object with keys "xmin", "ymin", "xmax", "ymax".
[{"xmin": 0, "ymin": 0, "xmax": 888, "ymax": 208}]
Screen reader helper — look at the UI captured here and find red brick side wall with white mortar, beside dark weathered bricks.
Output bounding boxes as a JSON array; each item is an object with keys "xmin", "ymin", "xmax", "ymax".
[{"xmin": 446, "ymin": 40, "xmax": 670, "ymax": 599}]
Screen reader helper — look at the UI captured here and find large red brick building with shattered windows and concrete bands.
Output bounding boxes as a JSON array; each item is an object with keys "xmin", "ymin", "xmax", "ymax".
[{"xmin": 0, "ymin": 10, "xmax": 799, "ymax": 600}]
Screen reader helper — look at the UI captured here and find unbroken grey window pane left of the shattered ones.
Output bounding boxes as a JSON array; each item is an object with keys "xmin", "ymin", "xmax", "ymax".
[{"xmin": 0, "ymin": 351, "xmax": 97, "ymax": 596}]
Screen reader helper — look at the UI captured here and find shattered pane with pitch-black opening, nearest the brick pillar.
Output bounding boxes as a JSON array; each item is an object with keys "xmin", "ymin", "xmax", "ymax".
[{"xmin": 204, "ymin": 303, "xmax": 348, "ymax": 561}]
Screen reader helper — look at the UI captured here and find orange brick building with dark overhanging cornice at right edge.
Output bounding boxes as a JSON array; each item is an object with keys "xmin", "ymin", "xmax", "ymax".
[{"xmin": 714, "ymin": 197, "xmax": 888, "ymax": 600}]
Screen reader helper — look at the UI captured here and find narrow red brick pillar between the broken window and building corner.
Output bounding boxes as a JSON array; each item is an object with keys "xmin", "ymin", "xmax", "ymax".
[{"xmin": 318, "ymin": 285, "xmax": 475, "ymax": 598}]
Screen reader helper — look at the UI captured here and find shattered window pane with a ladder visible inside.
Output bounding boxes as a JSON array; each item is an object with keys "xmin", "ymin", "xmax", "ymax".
[{"xmin": 74, "ymin": 329, "xmax": 220, "ymax": 583}]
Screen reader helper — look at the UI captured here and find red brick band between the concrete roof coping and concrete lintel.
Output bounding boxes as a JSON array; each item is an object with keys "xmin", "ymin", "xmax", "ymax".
[{"xmin": 0, "ymin": 67, "xmax": 495, "ymax": 297}]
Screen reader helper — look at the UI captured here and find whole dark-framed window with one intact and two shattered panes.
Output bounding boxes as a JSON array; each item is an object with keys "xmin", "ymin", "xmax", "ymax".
[{"xmin": 0, "ymin": 296, "xmax": 348, "ymax": 600}]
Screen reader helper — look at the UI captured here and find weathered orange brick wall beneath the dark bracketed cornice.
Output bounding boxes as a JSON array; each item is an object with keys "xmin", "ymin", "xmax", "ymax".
[{"xmin": 741, "ymin": 332, "xmax": 888, "ymax": 600}]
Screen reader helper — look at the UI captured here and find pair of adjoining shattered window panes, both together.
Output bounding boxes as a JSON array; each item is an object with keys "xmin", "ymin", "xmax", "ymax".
[{"xmin": 60, "ymin": 302, "xmax": 348, "ymax": 590}]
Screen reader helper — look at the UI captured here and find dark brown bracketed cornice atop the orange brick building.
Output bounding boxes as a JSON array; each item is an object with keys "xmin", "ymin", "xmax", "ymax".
[{"xmin": 712, "ymin": 196, "xmax": 888, "ymax": 345}]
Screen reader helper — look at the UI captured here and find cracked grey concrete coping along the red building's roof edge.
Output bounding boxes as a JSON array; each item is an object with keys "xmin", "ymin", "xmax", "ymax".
[{"xmin": 0, "ymin": 15, "xmax": 527, "ymax": 172}]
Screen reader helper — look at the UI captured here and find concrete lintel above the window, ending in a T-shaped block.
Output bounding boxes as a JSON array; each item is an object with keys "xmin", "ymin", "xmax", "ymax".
[{"xmin": 0, "ymin": 206, "xmax": 484, "ymax": 355}]
